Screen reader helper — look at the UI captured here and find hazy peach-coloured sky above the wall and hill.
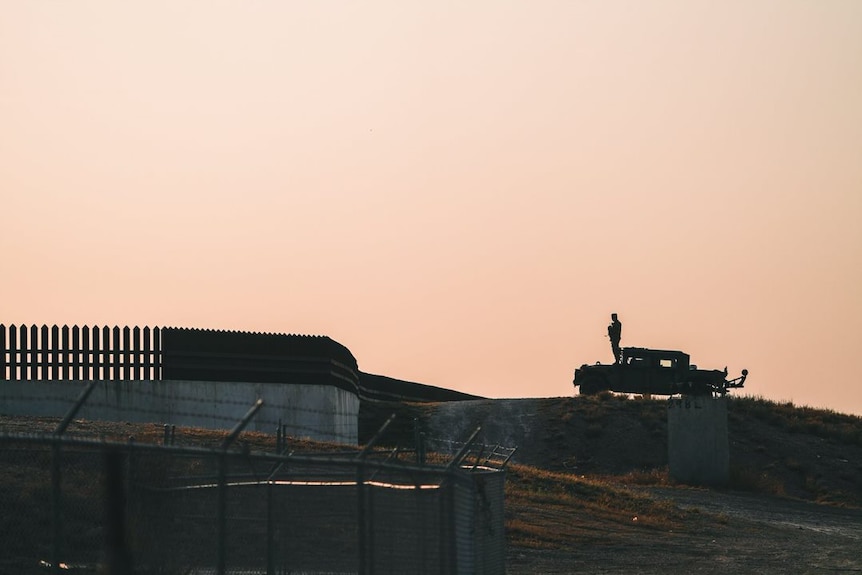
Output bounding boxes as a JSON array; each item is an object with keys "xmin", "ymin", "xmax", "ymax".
[{"xmin": 0, "ymin": 0, "xmax": 862, "ymax": 414}]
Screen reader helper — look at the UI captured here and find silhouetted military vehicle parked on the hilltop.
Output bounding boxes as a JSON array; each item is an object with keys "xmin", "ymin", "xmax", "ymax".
[{"xmin": 573, "ymin": 347, "xmax": 748, "ymax": 396}]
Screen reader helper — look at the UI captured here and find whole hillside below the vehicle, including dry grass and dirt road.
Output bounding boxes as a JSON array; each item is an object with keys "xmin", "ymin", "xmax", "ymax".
[{"xmin": 360, "ymin": 394, "xmax": 862, "ymax": 575}]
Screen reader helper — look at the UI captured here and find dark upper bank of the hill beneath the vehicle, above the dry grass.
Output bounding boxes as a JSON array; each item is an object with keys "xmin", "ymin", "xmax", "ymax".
[{"xmin": 360, "ymin": 393, "xmax": 862, "ymax": 507}]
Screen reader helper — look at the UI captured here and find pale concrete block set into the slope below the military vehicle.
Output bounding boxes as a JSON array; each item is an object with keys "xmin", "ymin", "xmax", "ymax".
[{"xmin": 667, "ymin": 396, "xmax": 730, "ymax": 486}]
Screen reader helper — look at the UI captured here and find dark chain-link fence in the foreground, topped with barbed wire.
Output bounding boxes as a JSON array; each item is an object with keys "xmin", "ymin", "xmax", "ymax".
[{"xmin": 0, "ymin": 413, "xmax": 505, "ymax": 574}]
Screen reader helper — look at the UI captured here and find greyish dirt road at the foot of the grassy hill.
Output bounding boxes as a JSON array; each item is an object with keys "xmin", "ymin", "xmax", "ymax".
[{"xmin": 507, "ymin": 488, "xmax": 862, "ymax": 575}]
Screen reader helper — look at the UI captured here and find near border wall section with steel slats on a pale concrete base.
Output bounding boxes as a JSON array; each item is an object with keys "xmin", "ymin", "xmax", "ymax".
[{"xmin": 0, "ymin": 324, "xmax": 359, "ymax": 444}]
